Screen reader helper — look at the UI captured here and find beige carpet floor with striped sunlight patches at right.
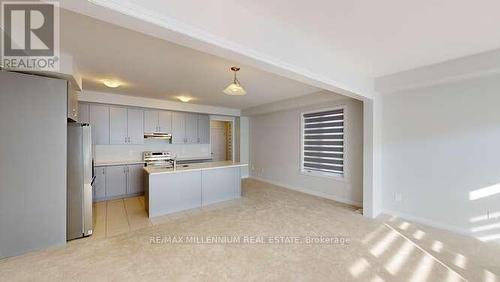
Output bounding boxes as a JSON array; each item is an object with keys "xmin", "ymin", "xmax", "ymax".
[{"xmin": 0, "ymin": 180, "xmax": 500, "ymax": 282}]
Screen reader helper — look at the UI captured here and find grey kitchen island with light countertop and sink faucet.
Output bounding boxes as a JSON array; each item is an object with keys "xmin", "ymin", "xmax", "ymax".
[{"xmin": 144, "ymin": 161, "xmax": 247, "ymax": 217}]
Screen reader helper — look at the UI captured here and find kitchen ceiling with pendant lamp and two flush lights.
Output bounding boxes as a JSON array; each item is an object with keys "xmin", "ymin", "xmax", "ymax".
[{"xmin": 60, "ymin": 10, "xmax": 319, "ymax": 109}]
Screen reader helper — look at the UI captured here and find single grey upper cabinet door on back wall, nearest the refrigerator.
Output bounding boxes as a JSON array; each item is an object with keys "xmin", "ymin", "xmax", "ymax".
[{"xmin": 90, "ymin": 104, "xmax": 109, "ymax": 145}]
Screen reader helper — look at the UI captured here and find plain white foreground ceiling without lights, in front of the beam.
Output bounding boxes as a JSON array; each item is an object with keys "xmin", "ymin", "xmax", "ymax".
[{"xmin": 62, "ymin": 0, "xmax": 500, "ymax": 97}]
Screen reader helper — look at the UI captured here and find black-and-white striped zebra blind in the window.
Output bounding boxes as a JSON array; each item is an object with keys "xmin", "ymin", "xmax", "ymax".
[{"xmin": 302, "ymin": 109, "xmax": 344, "ymax": 176}]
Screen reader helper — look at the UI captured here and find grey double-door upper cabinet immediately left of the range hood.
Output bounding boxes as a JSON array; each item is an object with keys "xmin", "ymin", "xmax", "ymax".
[{"xmin": 109, "ymin": 107, "xmax": 144, "ymax": 144}]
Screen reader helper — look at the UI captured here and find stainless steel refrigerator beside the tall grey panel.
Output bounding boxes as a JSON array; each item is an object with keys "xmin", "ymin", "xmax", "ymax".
[{"xmin": 66, "ymin": 123, "xmax": 93, "ymax": 240}]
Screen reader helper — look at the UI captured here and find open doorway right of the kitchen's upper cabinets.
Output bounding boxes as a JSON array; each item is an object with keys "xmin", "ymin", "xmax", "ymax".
[{"xmin": 210, "ymin": 120, "xmax": 233, "ymax": 162}]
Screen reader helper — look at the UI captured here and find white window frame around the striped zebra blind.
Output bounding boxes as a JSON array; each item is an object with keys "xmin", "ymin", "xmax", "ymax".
[{"xmin": 299, "ymin": 104, "xmax": 349, "ymax": 182}]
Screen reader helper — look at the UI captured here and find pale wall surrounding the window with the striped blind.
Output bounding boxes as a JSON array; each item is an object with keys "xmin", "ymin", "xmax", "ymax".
[{"xmin": 250, "ymin": 95, "xmax": 363, "ymax": 205}]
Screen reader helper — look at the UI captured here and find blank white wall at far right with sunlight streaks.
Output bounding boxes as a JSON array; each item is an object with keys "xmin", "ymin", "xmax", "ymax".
[{"xmin": 382, "ymin": 76, "xmax": 500, "ymax": 242}]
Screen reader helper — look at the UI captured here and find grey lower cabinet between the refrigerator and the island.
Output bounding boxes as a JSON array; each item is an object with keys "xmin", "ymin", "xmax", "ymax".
[{"xmin": 93, "ymin": 164, "xmax": 144, "ymax": 202}]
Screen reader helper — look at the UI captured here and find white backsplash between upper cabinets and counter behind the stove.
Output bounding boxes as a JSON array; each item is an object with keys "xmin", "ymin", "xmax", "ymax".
[{"xmin": 94, "ymin": 140, "xmax": 210, "ymax": 162}]
